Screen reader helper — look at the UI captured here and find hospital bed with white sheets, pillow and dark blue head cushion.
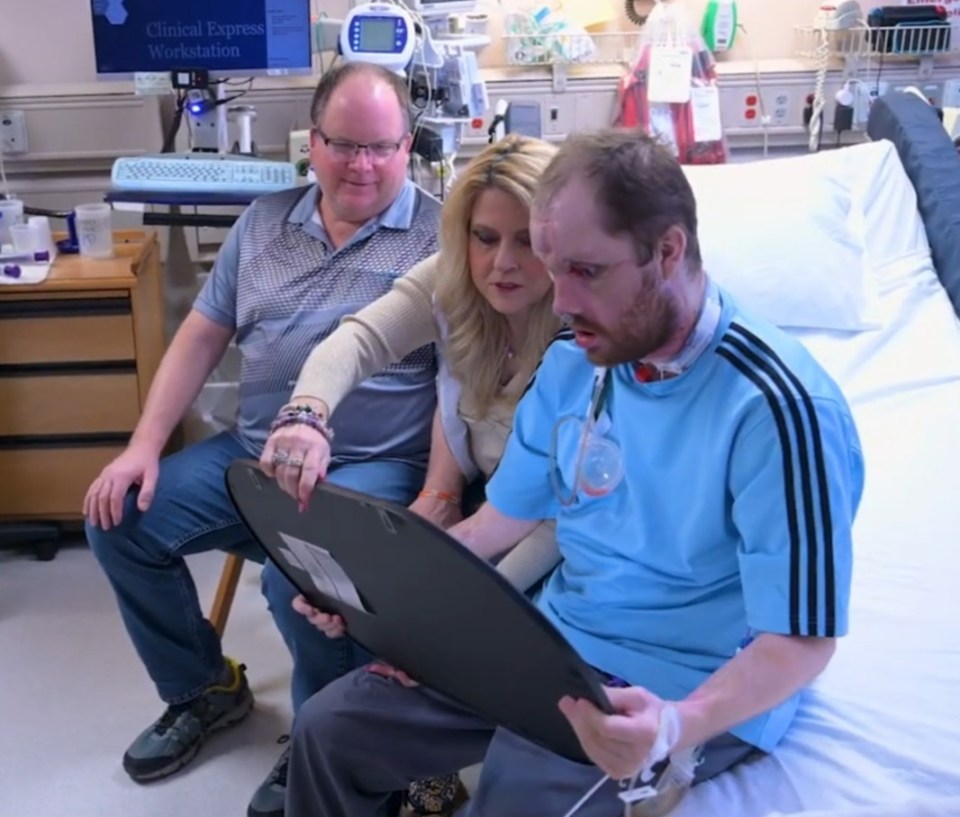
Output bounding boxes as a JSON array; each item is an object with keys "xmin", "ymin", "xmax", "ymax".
[{"xmin": 671, "ymin": 94, "xmax": 960, "ymax": 817}]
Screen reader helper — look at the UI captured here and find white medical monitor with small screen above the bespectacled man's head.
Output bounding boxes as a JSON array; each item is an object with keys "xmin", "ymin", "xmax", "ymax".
[{"xmin": 340, "ymin": 2, "xmax": 417, "ymax": 74}]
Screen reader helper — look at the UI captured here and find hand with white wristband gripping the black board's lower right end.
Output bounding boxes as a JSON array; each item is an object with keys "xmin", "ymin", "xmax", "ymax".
[{"xmin": 560, "ymin": 687, "xmax": 676, "ymax": 780}]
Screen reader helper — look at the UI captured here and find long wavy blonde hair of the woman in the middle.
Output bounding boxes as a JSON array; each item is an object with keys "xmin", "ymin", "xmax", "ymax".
[{"xmin": 437, "ymin": 134, "xmax": 560, "ymax": 417}]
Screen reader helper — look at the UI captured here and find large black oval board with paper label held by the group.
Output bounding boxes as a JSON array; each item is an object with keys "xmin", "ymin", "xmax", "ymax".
[{"xmin": 226, "ymin": 460, "xmax": 612, "ymax": 762}]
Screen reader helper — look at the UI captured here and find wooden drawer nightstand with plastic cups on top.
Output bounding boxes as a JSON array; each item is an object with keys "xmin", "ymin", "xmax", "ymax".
[{"xmin": 0, "ymin": 231, "xmax": 165, "ymax": 544}]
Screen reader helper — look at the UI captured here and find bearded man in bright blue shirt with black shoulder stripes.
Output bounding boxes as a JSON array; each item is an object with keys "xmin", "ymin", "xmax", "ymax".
[{"xmin": 287, "ymin": 131, "xmax": 863, "ymax": 817}]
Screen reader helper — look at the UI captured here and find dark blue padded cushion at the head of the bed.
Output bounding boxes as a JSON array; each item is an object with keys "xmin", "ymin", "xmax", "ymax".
[{"xmin": 867, "ymin": 91, "xmax": 960, "ymax": 315}]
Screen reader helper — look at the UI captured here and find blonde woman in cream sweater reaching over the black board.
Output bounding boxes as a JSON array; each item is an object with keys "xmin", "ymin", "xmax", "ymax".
[{"xmin": 261, "ymin": 136, "xmax": 560, "ymax": 814}]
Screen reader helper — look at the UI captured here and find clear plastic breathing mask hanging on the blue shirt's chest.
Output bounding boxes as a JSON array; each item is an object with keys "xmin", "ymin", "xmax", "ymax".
[{"xmin": 550, "ymin": 367, "xmax": 624, "ymax": 508}]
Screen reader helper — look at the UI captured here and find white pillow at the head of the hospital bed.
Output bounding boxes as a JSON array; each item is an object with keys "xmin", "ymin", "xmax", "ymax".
[{"xmin": 684, "ymin": 151, "xmax": 878, "ymax": 332}]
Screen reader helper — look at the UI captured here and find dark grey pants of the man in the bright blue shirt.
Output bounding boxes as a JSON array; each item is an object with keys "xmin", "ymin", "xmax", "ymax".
[{"xmin": 285, "ymin": 669, "xmax": 754, "ymax": 817}]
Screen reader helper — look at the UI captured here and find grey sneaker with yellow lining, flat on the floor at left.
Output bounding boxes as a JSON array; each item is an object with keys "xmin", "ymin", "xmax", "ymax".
[{"xmin": 123, "ymin": 658, "xmax": 253, "ymax": 783}]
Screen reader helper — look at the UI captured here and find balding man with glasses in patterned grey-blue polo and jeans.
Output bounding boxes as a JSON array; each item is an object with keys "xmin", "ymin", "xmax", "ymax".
[{"xmin": 84, "ymin": 63, "xmax": 440, "ymax": 815}]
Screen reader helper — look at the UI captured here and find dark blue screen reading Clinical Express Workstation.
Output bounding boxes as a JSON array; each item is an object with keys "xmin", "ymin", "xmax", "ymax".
[{"xmin": 90, "ymin": 0, "xmax": 312, "ymax": 76}]
